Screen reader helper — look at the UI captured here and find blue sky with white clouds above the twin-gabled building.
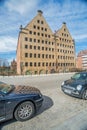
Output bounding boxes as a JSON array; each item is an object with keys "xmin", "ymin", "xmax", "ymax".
[{"xmin": 0, "ymin": 0, "xmax": 87, "ymax": 62}]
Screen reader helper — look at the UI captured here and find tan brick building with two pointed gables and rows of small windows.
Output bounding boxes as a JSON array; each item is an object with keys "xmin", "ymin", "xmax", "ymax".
[{"xmin": 17, "ymin": 10, "xmax": 75, "ymax": 74}]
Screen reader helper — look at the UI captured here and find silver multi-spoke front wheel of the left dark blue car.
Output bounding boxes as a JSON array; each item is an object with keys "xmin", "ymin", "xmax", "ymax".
[{"xmin": 14, "ymin": 101, "xmax": 35, "ymax": 121}]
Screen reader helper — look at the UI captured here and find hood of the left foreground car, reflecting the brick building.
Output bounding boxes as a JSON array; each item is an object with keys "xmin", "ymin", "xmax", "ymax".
[{"xmin": 13, "ymin": 86, "xmax": 40, "ymax": 94}]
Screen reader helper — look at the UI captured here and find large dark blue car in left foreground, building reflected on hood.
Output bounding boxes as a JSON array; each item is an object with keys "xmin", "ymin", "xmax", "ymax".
[{"xmin": 0, "ymin": 82, "xmax": 43, "ymax": 122}]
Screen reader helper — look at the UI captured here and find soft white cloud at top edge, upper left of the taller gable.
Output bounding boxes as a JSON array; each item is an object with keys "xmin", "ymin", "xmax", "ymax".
[{"xmin": 5, "ymin": 0, "xmax": 40, "ymax": 15}]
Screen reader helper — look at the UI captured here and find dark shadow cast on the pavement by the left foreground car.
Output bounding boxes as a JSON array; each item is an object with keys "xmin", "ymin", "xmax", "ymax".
[{"xmin": 0, "ymin": 95, "xmax": 53, "ymax": 130}]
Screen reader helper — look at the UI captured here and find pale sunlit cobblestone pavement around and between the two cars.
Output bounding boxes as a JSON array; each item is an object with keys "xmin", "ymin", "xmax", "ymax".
[{"xmin": 0, "ymin": 74, "xmax": 87, "ymax": 130}]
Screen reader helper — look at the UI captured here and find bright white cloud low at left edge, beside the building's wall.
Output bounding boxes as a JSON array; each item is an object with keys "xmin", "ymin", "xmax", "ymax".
[{"xmin": 0, "ymin": 36, "xmax": 17, "ymax": 52}]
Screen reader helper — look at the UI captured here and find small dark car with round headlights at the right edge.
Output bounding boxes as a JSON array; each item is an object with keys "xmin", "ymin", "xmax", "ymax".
[{"xmin": 61, "ymin": 72, "xmax": 87, "ymax": 99}]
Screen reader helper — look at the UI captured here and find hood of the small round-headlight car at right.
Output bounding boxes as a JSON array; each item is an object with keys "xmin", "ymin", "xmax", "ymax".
[{"xmin": 65, "ymin": 79, "xmax": 85, "ymax": 86}]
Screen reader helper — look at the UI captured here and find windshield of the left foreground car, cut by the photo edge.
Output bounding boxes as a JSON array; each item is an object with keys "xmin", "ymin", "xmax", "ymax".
[{"xmin": 0, "ymin": 82, "xmax": 13, "ymax": 94}]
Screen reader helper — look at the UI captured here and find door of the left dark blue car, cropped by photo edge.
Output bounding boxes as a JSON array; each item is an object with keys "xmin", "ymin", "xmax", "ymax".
[{"xmin": 0, "ymin": 94, "xmax": 5, "ymax": 121}]
